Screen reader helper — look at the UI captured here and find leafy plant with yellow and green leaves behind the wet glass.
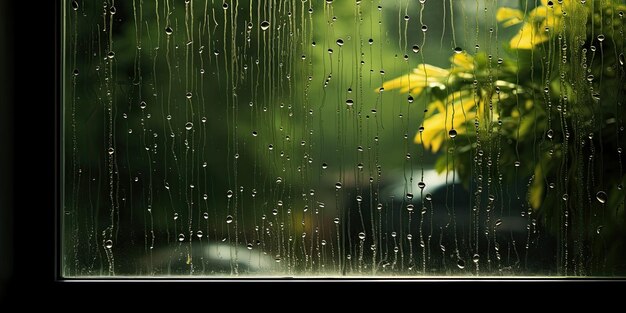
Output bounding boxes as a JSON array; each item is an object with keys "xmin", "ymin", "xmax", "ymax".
[{"xmin": 382, "ymin": 0, "xmax": 626, "ymax": 275}]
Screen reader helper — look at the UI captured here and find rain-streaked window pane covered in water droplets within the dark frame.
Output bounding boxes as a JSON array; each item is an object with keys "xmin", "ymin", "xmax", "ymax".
[{"xmin": 61, "ymin": 0, "xmax": 626, "ymax": 278}]
